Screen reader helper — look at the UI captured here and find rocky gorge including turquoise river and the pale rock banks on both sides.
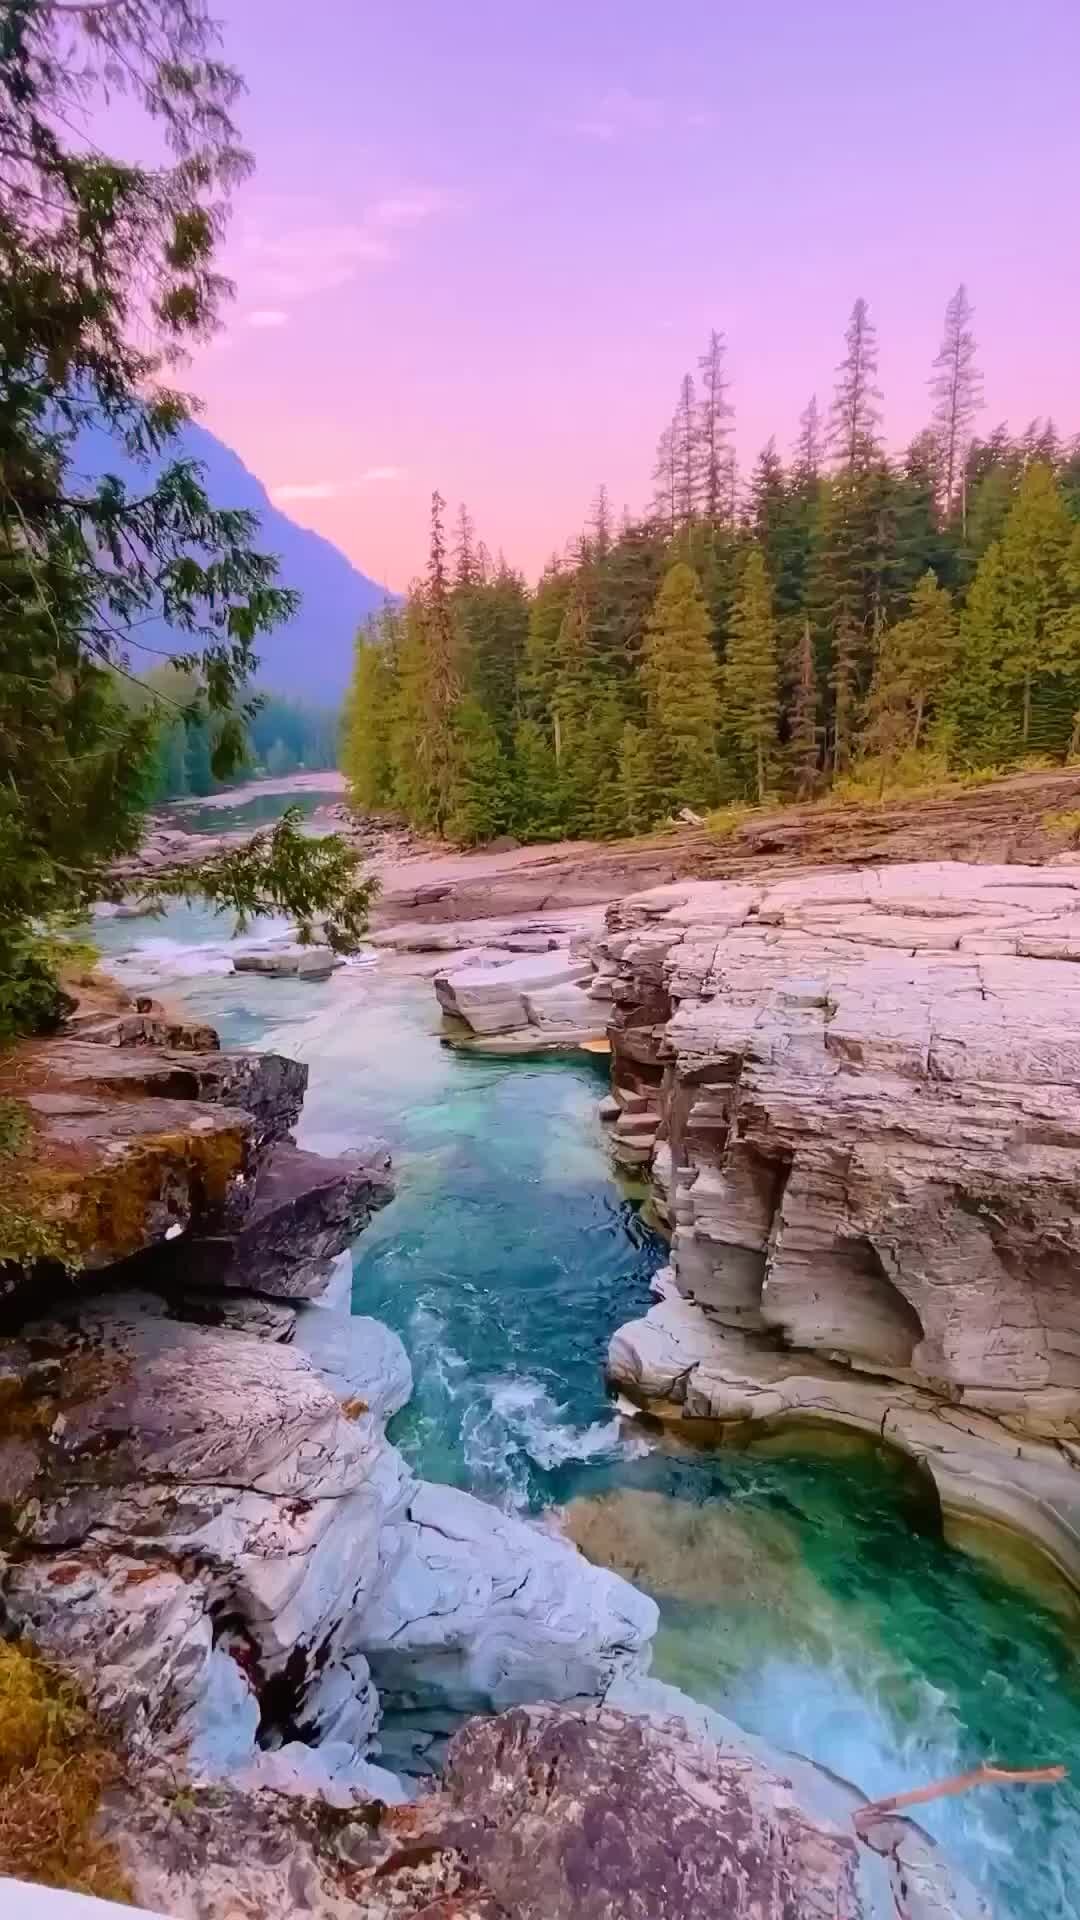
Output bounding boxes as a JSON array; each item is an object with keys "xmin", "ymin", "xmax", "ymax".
[{"xmin": 2, "ymin": 833, "xmax": 1080, "ymax": 1920}]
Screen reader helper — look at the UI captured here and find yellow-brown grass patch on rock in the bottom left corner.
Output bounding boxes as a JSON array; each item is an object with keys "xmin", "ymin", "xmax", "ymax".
[{"xmin": 0, "ymin": 1642, "xmax": 133, "ymax": 1905}]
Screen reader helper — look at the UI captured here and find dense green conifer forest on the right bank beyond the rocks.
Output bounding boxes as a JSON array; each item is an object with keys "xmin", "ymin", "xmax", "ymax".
[{"xmin": 344, "ymin": 299, "xmax": 1080, "ymax": 843}]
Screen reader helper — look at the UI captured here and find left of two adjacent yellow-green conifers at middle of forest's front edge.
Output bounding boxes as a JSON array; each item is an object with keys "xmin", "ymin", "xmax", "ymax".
[{"xmin": 642, "ymin": 561, "xmax": 719, "ymax": 818}]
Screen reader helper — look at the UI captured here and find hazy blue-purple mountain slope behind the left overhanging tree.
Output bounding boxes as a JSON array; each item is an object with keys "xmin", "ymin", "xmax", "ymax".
[{"xmin": 77, "ymin": 422, "xmax": 394, "ymax": 705}]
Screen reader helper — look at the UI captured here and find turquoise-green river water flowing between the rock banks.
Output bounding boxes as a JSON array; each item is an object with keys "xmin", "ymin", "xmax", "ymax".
[{"xmin": 102, "ymin": 908, "xmax": 1080, "ymax": 1920}]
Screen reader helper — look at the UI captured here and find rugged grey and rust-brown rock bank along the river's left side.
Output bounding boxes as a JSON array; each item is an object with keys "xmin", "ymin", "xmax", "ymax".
[{"xmin": 0, "ymin": 967, "xmax": 976, "ymax": 1920}]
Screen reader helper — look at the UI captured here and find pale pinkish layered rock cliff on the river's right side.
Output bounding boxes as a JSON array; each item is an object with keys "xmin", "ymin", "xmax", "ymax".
[{"xmin": 592, "ymin": 864, "xmax": 1080, "ymax": 1586}]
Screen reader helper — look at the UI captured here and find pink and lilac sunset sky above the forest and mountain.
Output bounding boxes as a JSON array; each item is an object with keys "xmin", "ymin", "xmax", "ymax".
[{"xmin": 190, "ymin": 0, "xmax": 1080, "ymax": 588}]
